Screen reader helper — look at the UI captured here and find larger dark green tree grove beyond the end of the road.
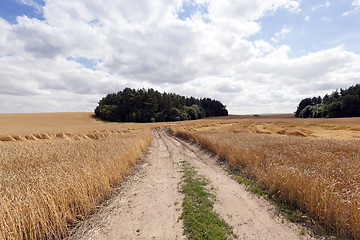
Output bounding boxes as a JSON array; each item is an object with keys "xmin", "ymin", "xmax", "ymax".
[{"xmin": 95, "ymin": 88, "xmax": 228, "ymax": 122}]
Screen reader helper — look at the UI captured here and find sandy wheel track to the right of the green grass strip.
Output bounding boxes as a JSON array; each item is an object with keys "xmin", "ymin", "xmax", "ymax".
[{"xmin": 160, "ymin": 132, "xmax": 312, "ymax": 240}]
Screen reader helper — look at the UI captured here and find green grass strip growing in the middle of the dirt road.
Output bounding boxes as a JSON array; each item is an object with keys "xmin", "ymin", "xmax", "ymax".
[{"xmin": 181, "ymin": 161, "xmax": 237, "ymax": 239}]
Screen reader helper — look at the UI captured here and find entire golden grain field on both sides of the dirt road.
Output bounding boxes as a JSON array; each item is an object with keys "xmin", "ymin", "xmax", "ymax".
[{"xmin": 0, "ymin": 113, "xmax": 360, "ymax": 239}]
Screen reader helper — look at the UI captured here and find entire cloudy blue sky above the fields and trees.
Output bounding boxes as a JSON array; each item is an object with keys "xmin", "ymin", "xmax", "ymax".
[{"xmin": 0, "ymin": 0, "xmax": 360, "ymax": 114}]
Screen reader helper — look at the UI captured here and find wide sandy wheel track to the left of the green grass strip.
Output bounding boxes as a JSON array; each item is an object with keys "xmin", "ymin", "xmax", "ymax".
[{"xmin": 70, "ymin": 131, "xmax": 184, "ymax": 240}]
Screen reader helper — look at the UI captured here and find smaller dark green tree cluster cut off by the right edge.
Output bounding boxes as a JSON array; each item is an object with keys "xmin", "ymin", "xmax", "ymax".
[{"xmin": 295, "ymin": 84, "xmax": 360, "ymax": 118}]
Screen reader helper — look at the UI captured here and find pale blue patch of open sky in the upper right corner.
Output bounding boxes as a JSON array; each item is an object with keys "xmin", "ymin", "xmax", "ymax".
[{"xmin": 250, "ymin": 0, "xmax": 360, "ymax": 57}]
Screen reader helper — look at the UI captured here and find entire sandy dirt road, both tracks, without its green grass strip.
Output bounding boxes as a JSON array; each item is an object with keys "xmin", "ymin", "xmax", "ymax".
[{"xmin": 72, "ymin": 130, "xmax": 311, "ymax": 239}]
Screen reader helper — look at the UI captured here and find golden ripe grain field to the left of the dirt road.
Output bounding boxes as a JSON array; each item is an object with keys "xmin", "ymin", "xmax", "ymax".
[{"xmin": 0, "ymin": 114, "xmax": 151, "ymax": 239}]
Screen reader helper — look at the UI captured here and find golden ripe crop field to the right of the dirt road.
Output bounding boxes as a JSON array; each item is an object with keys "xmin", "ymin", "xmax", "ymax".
[{"xmin": 167, "ymin": 115, "xmax": 360, "ymax": 239}]
